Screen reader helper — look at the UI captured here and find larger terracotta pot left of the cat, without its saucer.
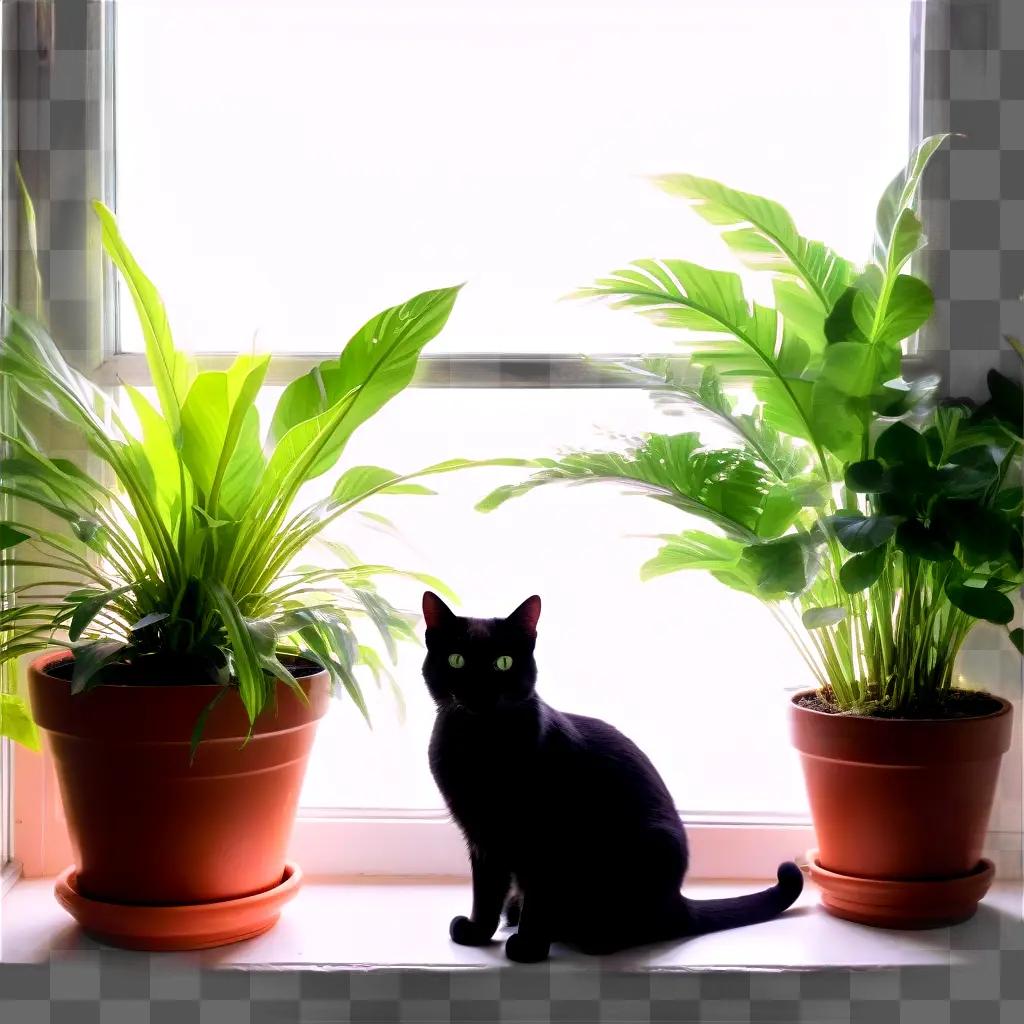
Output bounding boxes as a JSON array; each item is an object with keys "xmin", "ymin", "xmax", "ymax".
[{"xmin": 29, "ymin": 652, "xmax": 330, "ymax": 946}]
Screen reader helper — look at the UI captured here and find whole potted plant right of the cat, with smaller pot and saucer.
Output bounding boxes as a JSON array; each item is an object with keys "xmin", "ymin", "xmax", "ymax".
[{"xmin": 479, "ymin": 137, "xmax": 1024, "ymax": 927}]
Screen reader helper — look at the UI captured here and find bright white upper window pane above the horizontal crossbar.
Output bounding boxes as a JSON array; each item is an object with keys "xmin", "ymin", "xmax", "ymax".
[{"xmin": 117, "ymin": 0, "xmax": 909, "ymax": 352}]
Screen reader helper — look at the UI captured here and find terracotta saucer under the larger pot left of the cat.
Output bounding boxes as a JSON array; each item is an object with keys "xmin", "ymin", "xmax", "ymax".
[{"xmin": 54, "ymin": 862, "xmax": 302, "ymax": 952}]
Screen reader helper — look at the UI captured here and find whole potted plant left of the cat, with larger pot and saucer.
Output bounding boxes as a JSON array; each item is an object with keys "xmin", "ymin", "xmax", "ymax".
[{"xmin": 0, "ymin": 204, "xmax": 495, "ymax": 948}]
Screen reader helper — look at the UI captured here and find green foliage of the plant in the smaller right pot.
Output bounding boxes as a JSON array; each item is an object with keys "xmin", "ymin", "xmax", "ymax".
[{"xmin": 478, "ymin": 136, "xmax": 1024, "ymax": 711}]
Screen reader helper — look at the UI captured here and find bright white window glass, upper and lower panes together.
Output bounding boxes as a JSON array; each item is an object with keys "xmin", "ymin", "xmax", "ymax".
[{"xmin": 105, "ymin": 0, "xmax": 910, "ymax": 872}]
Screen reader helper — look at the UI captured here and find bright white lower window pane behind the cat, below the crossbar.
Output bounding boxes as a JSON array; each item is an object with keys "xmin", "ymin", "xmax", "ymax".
[{"xmin": 123, "ymin": 388, "xmax": 812, "ymax": 814}]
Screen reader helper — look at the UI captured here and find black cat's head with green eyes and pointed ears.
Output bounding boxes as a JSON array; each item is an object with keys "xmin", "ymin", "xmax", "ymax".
[{"xmin": 423, "ymin": 591, "xmax": 541, "ymax": 714}]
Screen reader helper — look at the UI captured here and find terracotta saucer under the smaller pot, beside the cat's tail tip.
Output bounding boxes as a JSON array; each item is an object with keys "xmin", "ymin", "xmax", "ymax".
[{"xmin": 807, "ymin": 850, "xmax": 995, "ymax": 928}]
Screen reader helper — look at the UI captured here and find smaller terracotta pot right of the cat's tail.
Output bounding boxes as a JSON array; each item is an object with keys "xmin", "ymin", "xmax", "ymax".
[{"xmin": 790, "ymin": 693, "xmax": 1013, "ymax": 927}]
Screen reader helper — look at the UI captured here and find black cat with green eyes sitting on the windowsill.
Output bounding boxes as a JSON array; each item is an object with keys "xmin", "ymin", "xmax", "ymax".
[{"xmin": 423, "ymin": 592, "xmax": 804, "ymax": 963}]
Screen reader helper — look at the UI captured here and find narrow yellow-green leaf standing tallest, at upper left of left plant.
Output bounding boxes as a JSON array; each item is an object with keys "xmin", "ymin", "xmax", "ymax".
[{"xmin": 92, "ymin": 201, "xmax": 196, "ymax": 443}]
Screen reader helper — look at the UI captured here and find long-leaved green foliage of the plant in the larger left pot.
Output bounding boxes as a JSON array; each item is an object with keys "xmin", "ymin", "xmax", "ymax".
[{"xmin": 0, "ymin": 204, "xmax": 487, "ymax": 743}]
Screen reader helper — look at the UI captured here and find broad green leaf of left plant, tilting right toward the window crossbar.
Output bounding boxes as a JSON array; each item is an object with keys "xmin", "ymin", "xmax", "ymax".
[{"xmin": 269, "ymin": 288, "xmax": 459, "ymax": 479}]
